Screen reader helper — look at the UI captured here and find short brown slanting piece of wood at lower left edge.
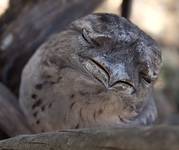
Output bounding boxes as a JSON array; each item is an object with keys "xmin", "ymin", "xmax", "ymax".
[{"xmin": 0, "ymin": 83, "xmax": 32, "ymax": 136}]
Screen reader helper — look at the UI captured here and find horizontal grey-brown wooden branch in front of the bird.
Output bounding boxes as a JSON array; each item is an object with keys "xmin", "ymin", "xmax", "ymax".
[{"xmin": 0, "ymin": 126, "xmax": 179, "ymax": 150}]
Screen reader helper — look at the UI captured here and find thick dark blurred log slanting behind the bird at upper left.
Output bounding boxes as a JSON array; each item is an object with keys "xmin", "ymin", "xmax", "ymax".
[{"xmin": 0, "ymin": 0, "xmax": 103, "ymax": 95}]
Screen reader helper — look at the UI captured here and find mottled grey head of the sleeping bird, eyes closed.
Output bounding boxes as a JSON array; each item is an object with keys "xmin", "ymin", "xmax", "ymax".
[{"xmin": 40, "ymin": 14, "xmax": 161, "ymax": 126}]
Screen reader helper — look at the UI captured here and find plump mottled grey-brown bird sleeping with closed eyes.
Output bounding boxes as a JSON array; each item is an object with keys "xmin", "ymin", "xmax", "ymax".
[{"xmin": 19, "ymin": 13, "xmax": 162, "ymax": 132}]
